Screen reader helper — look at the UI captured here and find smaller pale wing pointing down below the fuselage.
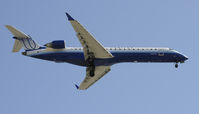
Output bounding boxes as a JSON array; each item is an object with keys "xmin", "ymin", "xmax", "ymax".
[{"xmin": 76, "ymin": 66, "xmax": 111, "ymax": 90}]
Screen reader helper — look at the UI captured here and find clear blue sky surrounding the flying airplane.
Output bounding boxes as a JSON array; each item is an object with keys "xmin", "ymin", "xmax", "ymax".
[{"xmin": 0, "ymin": 0, "xmax": 199, "ymax": 114}]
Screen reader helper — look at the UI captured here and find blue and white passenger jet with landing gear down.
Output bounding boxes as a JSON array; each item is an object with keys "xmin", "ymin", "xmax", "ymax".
[{"xmin": 6, "ymin": 13, "xmax": 188, "ymax": 90}]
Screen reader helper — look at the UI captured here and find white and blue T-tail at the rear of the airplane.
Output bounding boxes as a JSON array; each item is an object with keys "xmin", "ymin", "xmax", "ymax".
[{"xmin": 6, "ymin": 25, "xmax": 40, "ymax": 52}]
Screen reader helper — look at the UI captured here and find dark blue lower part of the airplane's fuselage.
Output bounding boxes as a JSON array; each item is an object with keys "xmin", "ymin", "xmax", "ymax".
[{"xmin": 28, "ymin": 51, "xmax": 186, "ymax": 66}]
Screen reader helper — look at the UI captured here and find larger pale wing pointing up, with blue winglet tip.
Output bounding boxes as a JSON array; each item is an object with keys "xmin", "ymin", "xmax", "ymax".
[{"xmin": 66, "ymin": 13, "xmax": 113, "ymax": 59}]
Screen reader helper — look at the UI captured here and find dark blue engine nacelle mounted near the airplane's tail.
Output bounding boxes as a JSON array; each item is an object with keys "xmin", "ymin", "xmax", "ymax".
[{"xmin": 44, "ymin": 40, "xmax": 65, "ymax": 49}]
